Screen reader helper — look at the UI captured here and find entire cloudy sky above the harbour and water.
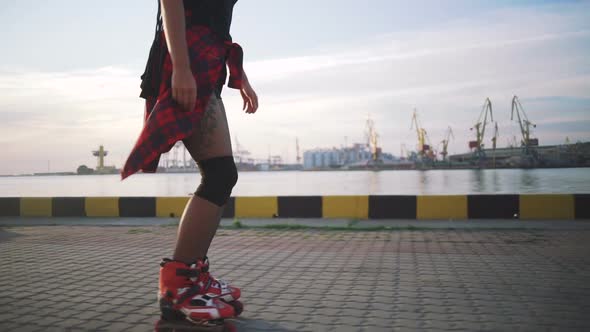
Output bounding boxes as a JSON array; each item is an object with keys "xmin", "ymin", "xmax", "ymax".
[{"xmin": 0, "ymin": 0, "xmax": 590, "ymax": 174}]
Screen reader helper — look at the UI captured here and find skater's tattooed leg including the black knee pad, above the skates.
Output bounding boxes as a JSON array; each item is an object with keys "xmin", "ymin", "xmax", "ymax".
[{"xmin": 173, "ymin": 95, "xmax": 237, "ymax": 263}]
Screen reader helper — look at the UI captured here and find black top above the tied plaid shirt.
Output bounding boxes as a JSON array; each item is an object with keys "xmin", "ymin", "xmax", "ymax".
[{"xmin": 184, "ymin": 0, "xmax": 238, "ymax": 40}]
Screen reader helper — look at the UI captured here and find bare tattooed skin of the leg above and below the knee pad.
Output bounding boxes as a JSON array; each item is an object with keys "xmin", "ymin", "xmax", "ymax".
[{"xmin": 173, "ymin": 96, "xmax": 232, "ymax": 263}]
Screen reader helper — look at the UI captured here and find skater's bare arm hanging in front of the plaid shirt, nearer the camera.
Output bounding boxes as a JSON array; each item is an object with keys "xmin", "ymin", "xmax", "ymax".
[{"xmin": 160, "ymin": 0, "xmax": 197, "ymax": 111}]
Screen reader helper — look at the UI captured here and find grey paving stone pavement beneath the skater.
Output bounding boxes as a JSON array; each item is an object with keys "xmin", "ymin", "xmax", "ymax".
[{"xmin": 0, "ymin": 226, "xmax": 590, "ymax": 331}]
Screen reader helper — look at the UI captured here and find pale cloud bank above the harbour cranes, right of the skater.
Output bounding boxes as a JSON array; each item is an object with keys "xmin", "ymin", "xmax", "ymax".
[{"xmin": 230, "ymin": 4, "xmax": 590, "ymax": 160}]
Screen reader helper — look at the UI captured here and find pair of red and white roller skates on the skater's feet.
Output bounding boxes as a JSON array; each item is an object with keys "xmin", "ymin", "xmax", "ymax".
[{"xmin": 156, "ymin": 258, "xmax": 235, "ymax": 331}]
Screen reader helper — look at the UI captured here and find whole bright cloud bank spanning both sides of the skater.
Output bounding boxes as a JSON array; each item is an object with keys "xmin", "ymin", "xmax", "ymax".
[{"xmin": 0, "ymin": 2, "xmax": 590, "ymax": 173}]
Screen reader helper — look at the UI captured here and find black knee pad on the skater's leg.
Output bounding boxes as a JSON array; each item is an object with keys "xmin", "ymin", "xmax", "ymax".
[{"xmin": 195, "ymin": 156, "xmax": 238, "ymax": 207}]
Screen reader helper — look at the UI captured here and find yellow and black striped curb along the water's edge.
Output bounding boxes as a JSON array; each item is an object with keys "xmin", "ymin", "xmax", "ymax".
[{"xmin": 0, "ymin": 194, "xmax": 590, "ymax": 220}]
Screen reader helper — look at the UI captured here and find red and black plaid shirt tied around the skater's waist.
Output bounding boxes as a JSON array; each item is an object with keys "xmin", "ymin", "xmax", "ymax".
[{"xmin": 121, "ymin": 26, "xmax": 243, "ymax": 180}]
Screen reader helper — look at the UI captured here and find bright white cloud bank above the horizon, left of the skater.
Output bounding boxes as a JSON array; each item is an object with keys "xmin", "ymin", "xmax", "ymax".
[{"xmin": 0, "ymin": 67, "xmax": 143, "ymax": 173}]
